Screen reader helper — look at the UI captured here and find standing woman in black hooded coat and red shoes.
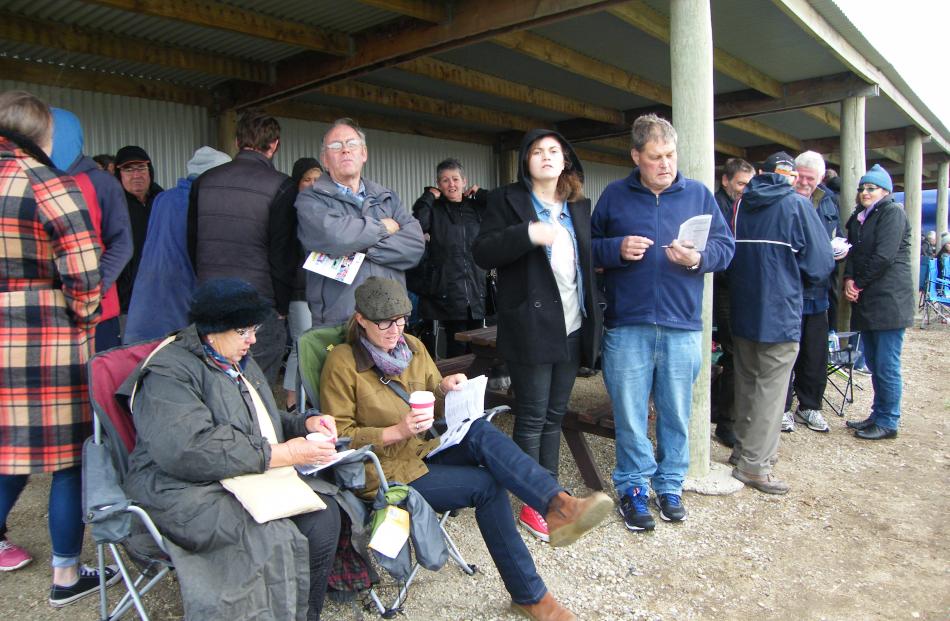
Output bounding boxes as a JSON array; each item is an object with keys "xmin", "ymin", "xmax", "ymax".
[{"xmin": 474, "ymin": 129, "xmax": 602, "ymax": 541}]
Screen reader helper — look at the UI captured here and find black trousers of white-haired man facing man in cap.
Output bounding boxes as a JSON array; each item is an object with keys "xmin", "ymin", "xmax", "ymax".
[{"xmin": 785, "ymin": 311, "xmax": 828, "ymax": 412}]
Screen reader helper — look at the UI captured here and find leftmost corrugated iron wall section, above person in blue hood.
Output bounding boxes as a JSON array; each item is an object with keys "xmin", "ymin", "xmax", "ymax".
[{"xmin": 0, "ymin": 80, "xmax": 213, "ymax": 188}]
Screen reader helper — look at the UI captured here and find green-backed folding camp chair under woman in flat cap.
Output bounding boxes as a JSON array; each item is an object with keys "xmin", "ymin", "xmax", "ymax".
[{"xmin": 297, "ymin": 325, "xmax": 511, "ymax": 619}]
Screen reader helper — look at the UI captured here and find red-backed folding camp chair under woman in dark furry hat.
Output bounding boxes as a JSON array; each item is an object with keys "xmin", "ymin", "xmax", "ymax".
[{"xmin": 83, "ymin": 340, "xmax": 398, "ymax": 621}]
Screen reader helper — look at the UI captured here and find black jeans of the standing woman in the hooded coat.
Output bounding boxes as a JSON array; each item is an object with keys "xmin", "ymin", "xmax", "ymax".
[{"xmin": 507, "ymin": 330, "xmax": 581, "ymax": 479}]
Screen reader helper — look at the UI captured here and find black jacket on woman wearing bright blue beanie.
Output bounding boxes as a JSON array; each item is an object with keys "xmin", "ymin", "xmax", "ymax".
[{"xmin": 844, "ymin": 196, "xmax": 916, "ymax": 330}]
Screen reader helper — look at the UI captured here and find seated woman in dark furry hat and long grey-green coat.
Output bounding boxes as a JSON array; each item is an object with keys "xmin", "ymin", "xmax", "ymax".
[{"xmin": 119, "ymin": 278, "xmax": 341, "ymax": 621}]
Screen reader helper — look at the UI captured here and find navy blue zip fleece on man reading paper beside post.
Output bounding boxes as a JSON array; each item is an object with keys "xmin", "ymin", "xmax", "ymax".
[{"xmin": 591, "ymin": 168, "xmax": 735, "ymax": 330}]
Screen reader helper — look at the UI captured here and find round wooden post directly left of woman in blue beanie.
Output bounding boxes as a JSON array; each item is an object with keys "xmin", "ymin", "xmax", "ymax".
[{"xmin": 838, "ymin": 97, "xmax": 865, "ymax": 330}]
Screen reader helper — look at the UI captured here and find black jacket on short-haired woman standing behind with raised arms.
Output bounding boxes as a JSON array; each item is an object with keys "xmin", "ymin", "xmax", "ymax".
[{"xmin": 407, "ymin": 190, "xmax": 488, "ymax": 321}]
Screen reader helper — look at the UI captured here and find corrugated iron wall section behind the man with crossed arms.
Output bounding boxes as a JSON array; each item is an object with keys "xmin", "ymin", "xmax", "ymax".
[{"xmin": 274, "ymin": 118, "xmax": 496, "ymax": 209}]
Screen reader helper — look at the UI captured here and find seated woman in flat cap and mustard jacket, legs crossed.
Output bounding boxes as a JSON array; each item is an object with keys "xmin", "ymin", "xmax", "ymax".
[{"xmin": 320, "ymin": 277, "xmax": 613, "ymax": 621}]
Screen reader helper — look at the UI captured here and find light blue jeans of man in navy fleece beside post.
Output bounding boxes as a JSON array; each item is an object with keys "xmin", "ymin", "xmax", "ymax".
[{"xmin": 603, "ymin": 324, "xmax": 702, "ymax": 494}]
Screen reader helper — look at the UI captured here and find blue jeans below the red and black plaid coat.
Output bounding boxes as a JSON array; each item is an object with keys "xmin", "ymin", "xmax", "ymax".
[{"xmin": 0, "ymin": 466, "xmax": 84, "ymax": 567}]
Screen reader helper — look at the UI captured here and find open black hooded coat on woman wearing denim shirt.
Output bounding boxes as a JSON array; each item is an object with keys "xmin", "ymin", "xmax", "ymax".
[{"xmin": 472, "ymin": 129, "xmax": 603, "ymax": 368}]
